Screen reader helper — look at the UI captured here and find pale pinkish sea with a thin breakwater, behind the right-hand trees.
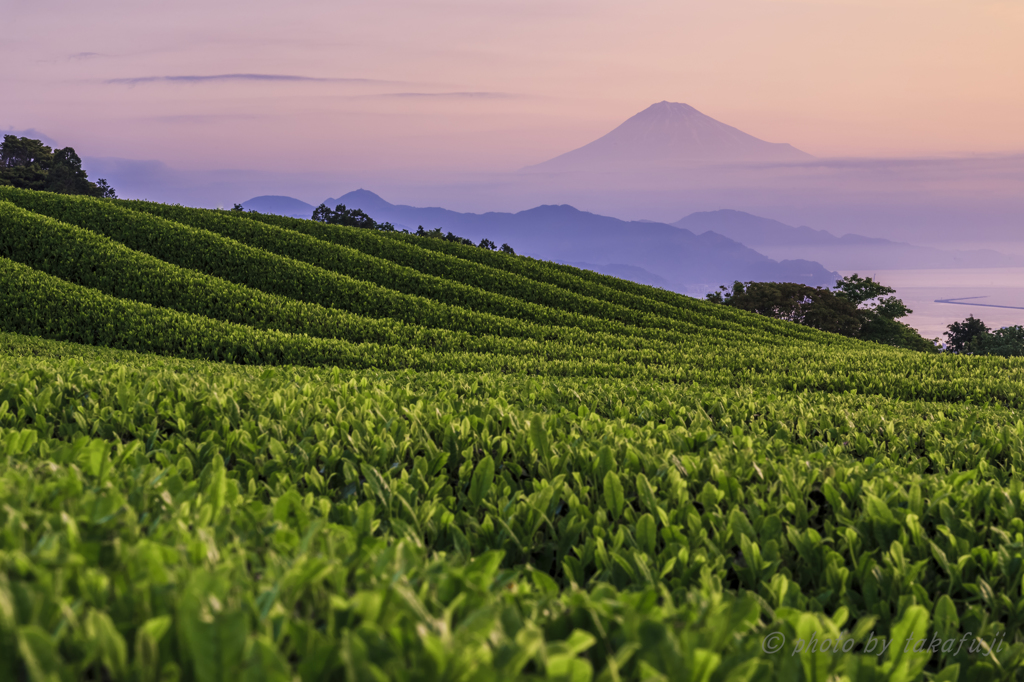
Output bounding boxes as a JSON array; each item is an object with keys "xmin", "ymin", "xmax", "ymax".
[{"xmin": 841, "ymin": 267, "xmax": 1024, "ymax": 341}]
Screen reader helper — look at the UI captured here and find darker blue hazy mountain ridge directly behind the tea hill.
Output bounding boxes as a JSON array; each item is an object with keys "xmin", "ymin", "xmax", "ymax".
[{"xmin": 326, "ymin": 189, "xmax": 838, "ymax": 294}]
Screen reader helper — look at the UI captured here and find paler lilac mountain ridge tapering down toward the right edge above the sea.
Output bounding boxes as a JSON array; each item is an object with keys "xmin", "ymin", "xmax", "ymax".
[{"xmin": 672, "ymin": 210, "xmax": 1024, "ymax": 270}]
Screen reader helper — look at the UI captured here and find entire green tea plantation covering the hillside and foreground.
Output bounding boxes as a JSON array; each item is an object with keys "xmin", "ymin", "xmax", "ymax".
[{"xmin": 0, "ymin": 187, "xmax": 1024, "ymax": 682}]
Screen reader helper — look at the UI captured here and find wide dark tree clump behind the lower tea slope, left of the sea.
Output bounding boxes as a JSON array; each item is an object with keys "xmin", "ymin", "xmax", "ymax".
[{"xmin": 707, "ymin": 273, "xmax": 936, "ymax": 352}]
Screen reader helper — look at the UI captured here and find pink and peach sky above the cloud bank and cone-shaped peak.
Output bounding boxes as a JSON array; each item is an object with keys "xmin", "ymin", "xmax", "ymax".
[{"xmin": 0, "ymin": 0, "xmax": 1024, "ymax": 172}]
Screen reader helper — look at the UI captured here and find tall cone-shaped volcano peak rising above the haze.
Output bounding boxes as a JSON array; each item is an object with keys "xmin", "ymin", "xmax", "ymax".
[{"xmin": 524, "ymin": 101, "xmax": 813, "ymax": 172}]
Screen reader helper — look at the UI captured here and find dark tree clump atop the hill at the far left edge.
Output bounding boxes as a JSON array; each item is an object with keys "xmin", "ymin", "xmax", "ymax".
[{"xmin": 0, "ymin": 135, "xmax": 117, "ymax": 198}]
